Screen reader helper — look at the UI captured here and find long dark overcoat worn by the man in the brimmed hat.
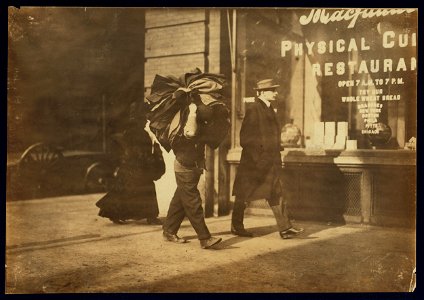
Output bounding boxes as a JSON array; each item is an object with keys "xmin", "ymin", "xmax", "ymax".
[{"xmin": 233, "ymin": 98, "xmax": 283, "ymax": 201}]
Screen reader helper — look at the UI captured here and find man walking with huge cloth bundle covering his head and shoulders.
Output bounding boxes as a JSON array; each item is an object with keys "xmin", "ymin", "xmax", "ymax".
[{"xmin": 147, "ymin": 69, "xmax": 229, "ymax": 249}]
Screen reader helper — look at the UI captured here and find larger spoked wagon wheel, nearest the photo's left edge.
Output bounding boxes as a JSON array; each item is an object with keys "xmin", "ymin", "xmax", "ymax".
[{"xmin": 18, "ymin": 143, "xmax": 63, "ymax": 197}]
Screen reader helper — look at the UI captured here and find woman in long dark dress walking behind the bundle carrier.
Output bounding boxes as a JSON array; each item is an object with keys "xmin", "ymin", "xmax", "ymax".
[{"xmin": 96, "ymin": 113, "xmax": 165, "ymax": 225}]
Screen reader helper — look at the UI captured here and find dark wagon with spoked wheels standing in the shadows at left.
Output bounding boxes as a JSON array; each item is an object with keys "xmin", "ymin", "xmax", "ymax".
[{"xmin": 6, "ymin": 142, "xmax": 119, "ymax": 200}]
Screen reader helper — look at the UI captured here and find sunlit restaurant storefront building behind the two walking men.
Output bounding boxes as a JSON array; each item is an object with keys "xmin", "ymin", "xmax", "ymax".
[{"xmin": 145, "ymin": 8, "xmax": 417, "ymax": 226}]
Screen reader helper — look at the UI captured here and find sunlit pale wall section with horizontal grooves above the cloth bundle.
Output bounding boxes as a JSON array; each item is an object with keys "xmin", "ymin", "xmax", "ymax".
[{"xmin": 144, "ymin": 8, "xmax": 220, "ymax": 88}]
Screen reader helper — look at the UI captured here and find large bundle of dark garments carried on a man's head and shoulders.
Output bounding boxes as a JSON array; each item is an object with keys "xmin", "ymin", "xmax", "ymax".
[{"xmin": 146, "ymin": 68, "xmax": 230, "ymax": 152}]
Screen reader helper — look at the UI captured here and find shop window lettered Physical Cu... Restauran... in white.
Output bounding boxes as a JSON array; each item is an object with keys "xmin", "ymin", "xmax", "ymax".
[{"xmin": 238, "ymin": 8, "xmax": 418, "ymax": 149}]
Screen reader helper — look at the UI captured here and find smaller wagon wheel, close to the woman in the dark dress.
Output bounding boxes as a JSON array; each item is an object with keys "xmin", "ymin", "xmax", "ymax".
[{"xmin": 84, "ymin": 162, "xmax": 115, "ymax": 193}]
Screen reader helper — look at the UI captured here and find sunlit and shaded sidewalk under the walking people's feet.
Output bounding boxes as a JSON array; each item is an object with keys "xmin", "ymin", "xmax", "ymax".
[{"xmin": 6, "ymin": 194, "xmax": 416, "ymax": 293}]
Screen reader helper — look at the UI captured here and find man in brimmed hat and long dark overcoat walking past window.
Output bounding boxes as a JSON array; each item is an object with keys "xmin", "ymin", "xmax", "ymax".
[{"xmin": 231, "ymin": 79, "xmax": 303, "ymax": 239}]
